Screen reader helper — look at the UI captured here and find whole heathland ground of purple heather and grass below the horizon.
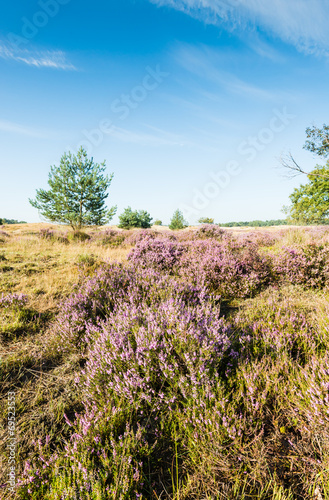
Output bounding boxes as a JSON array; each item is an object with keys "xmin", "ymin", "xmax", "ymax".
[{"xmin": 0, "ymin": 224, "xmax": 329, "ymax": 500}]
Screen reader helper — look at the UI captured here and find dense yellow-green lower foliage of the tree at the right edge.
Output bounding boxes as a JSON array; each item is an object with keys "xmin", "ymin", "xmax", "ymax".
[{"xmin": 284, "ymin": 161, "xmax": 329, "ymax": 224}]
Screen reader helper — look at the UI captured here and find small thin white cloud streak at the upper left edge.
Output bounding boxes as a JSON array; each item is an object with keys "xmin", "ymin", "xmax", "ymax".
[{"xmin": 0, "ymin": 41, "xmax": 76, "ymax": 70}]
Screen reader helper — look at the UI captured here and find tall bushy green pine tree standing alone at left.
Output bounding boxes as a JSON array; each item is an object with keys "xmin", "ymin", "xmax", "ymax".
[{"xmin": 29, "ymin": 147, "xmax": 116, "ymax": 230}]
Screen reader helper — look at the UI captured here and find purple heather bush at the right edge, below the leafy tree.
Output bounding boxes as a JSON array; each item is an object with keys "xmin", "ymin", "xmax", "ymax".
[{"xmin": 274, "ymin": 243, "xmax": 329, "ymax": 288}]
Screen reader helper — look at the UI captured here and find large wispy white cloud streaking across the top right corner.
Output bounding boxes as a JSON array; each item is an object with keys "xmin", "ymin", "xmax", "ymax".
[{"xmin": 150, "ymin": 0, "xmax": 329, "ymax": 55}]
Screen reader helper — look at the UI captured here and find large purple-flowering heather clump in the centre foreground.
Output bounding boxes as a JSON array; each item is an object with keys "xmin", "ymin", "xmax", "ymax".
[{"xmin": 83, "ymin": 292, "xmax": 230, "ymax": 411}]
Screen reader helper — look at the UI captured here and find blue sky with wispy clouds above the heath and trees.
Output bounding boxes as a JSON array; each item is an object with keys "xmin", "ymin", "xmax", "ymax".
[{"xmin": 0, "ymin": 0, "xmax": 329, "ymax": 224}]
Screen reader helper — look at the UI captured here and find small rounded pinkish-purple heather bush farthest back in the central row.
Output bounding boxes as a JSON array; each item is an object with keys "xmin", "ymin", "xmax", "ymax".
[{"xmin": 128, "ymin": 237, "xmax": 184, "ymax": 271}]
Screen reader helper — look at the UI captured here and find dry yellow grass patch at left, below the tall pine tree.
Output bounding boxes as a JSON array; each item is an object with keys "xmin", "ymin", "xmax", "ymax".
[{"xmin": 0, "ymin": 224, "xmax": 130, "ymax": 312}]
